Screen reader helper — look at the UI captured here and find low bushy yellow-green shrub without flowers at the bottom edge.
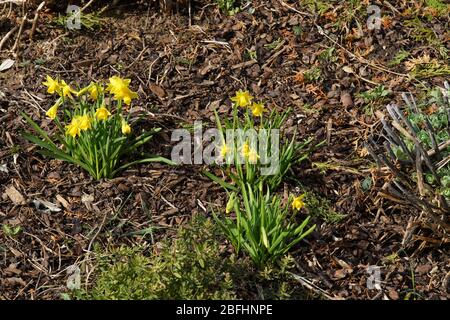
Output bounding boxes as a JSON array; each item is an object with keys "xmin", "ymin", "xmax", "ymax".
[{"xmin": 74, "ymin": 217, "xmax": 240, "ymax": 300}]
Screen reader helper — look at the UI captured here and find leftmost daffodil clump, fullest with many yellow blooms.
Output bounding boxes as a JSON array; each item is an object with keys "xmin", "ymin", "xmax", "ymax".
[{"xmin": 22, "ymin": 76, "xmax": 171, "ymax": 179}]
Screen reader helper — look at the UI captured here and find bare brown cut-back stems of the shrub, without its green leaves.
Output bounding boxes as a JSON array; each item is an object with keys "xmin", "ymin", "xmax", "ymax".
[{"xmin": 366, "ymin": 82, "xmax": 450, "ymax": 246}]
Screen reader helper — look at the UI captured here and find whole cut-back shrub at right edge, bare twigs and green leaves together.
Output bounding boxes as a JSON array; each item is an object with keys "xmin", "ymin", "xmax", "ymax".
[{"xmin": 366, "ymin": 83, "xmax": 450, "ymax": 243}]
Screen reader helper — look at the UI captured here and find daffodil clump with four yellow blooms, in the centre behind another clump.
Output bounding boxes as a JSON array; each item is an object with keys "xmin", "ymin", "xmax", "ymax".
[{"xmin": 206, "ymin": 90, "xmax": 312, "ymax": 190}]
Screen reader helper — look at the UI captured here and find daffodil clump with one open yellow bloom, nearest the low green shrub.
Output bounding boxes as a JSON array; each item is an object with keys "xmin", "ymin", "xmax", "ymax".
[{"xmin": 214, "ymin": 182, "xmax": 315, "ymax": 268}]
